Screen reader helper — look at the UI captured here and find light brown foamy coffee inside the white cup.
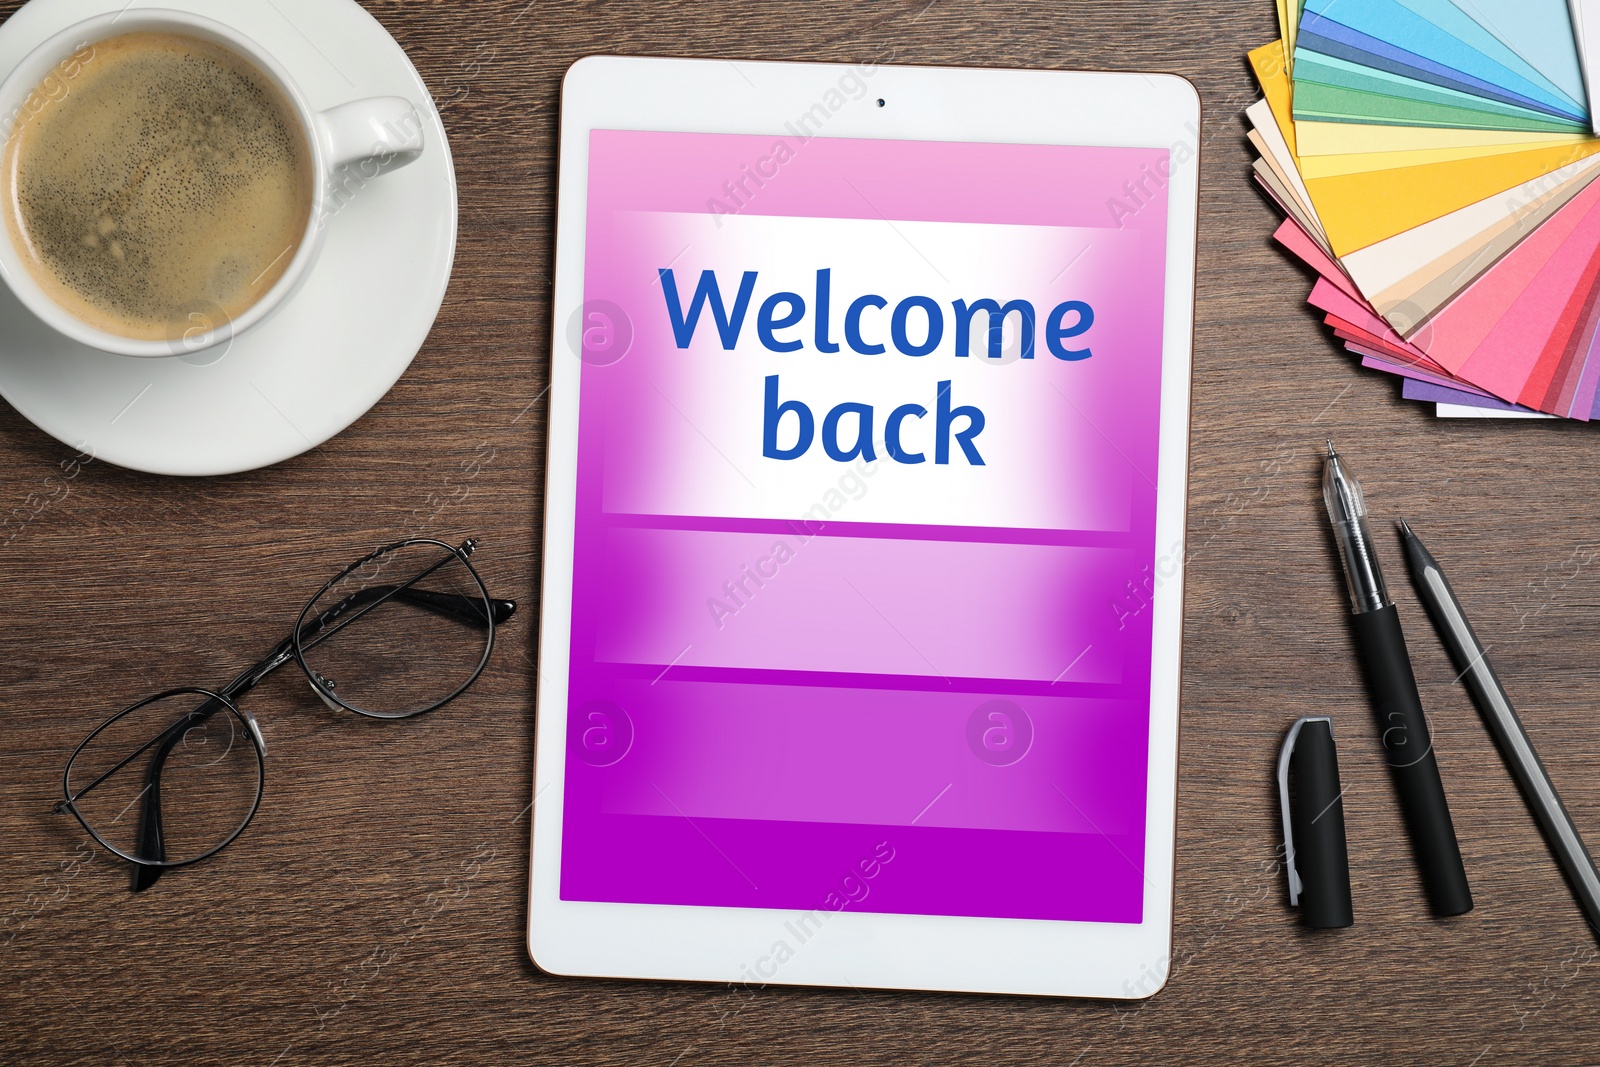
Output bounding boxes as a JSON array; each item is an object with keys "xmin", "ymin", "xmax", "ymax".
[{"xmin": 0, "ymin": 32, "xmax": 314, "ymax": 341}]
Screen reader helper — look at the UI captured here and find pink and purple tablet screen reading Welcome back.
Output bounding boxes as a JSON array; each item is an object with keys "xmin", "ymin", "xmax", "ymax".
[{"xmin": 560, "ymin": 127, "xmax": 1181, "ymax": 923}]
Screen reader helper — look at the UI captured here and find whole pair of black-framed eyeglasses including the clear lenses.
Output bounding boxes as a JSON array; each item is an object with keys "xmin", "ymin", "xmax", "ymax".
[{"xmin": 54, "ymin": 537, "xmax": 517, "ymax": 893}]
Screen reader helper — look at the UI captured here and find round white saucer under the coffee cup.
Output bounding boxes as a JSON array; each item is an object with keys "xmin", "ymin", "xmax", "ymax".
[{"xmin": 0, "ymin": 0, "xmax": 456, "ymax": 475}]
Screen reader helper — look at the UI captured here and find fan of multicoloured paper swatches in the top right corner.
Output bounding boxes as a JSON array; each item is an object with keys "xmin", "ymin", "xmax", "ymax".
[{"xmin": 1246, "ymin": 0, "xmax": 1600, "ymax": 421}]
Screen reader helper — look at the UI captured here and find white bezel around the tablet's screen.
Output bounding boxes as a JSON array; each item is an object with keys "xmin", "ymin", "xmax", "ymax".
[{"xmin": 528, "ymin": 56, "xmax": 1200, "ymax": 998}]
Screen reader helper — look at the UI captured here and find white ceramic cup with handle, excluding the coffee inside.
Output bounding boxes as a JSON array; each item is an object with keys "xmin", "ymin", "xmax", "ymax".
[{"xmin": 0, "ymin": 8, "xmax": 422, "ymax": 357}]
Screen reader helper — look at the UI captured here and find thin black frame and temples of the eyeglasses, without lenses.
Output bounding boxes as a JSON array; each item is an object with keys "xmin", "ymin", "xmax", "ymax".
[{"xmin": 53, "ymin": 537, "xmax": 517, "ymax": 889}]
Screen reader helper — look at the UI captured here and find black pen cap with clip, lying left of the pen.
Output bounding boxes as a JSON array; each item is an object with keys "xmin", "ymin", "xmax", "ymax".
[{"xmin": 1278, "ymin": 715, "xmax": 1355, "ymax": 929}]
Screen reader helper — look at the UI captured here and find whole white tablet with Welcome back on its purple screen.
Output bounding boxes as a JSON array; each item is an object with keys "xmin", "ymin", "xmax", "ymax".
[{"xmin": 528, "ymin": 58, "xmax": 1200, "ymax": 998}]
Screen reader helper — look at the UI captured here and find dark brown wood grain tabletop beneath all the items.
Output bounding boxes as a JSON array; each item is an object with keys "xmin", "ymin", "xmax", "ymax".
[{"xmin": 0, "ymin": 0, "xmax": 1600, "ymax": 1067}]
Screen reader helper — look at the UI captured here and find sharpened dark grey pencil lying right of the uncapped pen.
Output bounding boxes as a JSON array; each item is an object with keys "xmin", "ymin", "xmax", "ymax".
[{"xmin": 1400, "ymin": 520, "xmax": 1600, "ymax": 934}]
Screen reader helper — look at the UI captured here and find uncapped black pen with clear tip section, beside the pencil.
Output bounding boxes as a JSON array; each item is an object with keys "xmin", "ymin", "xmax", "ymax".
[{"xmin": 1322, "ymin": 442, "xmax": 1472, "ymax": 915}]
